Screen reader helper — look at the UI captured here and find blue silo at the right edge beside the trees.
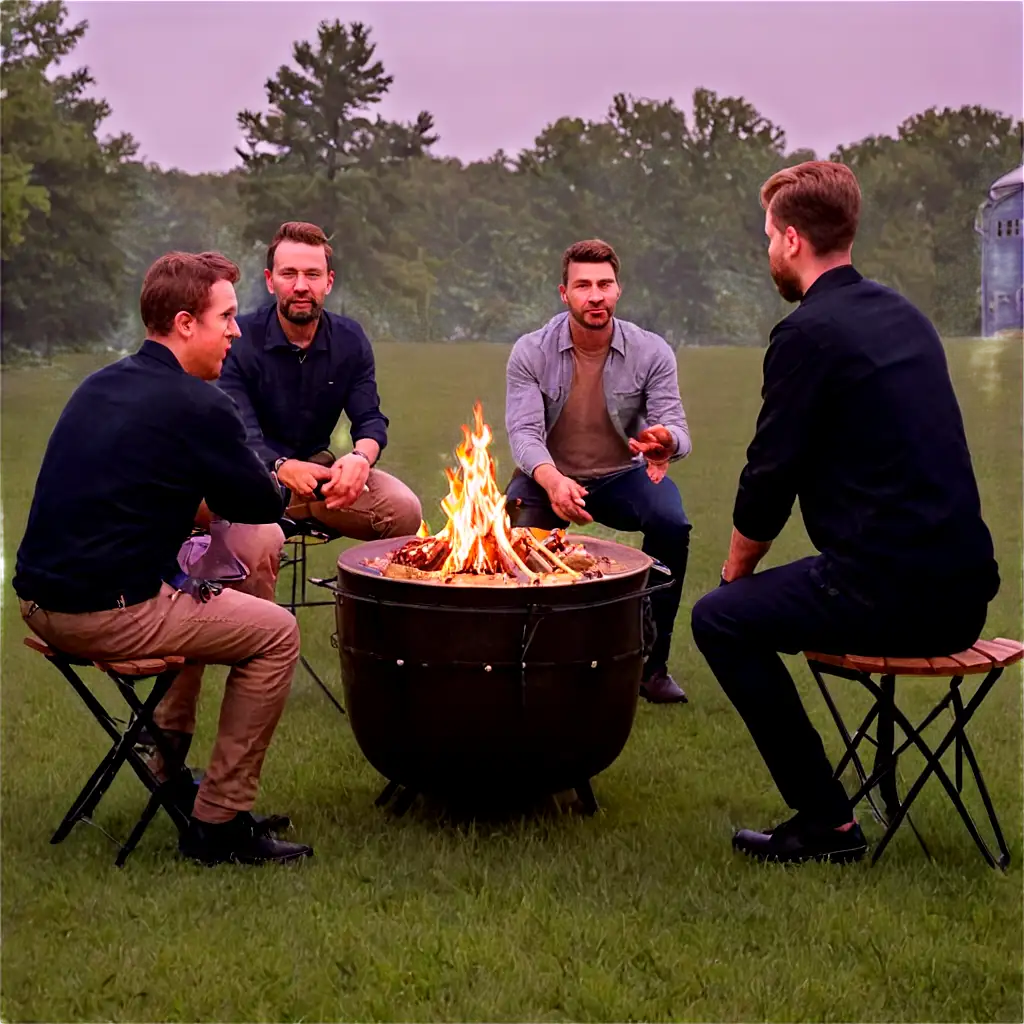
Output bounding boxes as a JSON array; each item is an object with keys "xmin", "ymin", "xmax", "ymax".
[{"xmin": 974, "ymin": 166, "xmax": 1024, "ymax": 338}]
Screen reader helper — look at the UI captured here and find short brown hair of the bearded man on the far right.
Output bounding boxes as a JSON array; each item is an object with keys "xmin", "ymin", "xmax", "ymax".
[{"xmin": 761, "ymin": 160, "xmax": 860, "ymax": 256}]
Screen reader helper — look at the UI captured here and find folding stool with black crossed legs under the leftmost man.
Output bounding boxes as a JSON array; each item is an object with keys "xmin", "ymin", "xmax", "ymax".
[{"xmin": 25, "ymin": 637, "xmax": 188, "ymax": 867}]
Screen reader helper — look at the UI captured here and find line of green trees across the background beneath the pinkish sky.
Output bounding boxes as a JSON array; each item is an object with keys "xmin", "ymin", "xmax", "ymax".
[{"xmin": 0, "ymin": 0, "xmax": 1024, "ymax": 361}]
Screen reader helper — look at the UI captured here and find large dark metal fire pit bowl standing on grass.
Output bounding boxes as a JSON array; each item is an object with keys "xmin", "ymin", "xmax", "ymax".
[{"xmin": 332, "ymin": 537, "xmax": 665, "ymax": 811}]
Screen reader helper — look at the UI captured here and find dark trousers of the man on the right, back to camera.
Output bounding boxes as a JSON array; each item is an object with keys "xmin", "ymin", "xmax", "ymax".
[{"xmin": 691, "ymin": 557, "xmax": 987, "ymax": 824}]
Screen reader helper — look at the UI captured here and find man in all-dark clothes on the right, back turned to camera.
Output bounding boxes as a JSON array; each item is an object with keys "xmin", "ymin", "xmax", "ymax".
[{"xmin": 692, "ymin": 162, "xmax": 999, "ymax": 861}]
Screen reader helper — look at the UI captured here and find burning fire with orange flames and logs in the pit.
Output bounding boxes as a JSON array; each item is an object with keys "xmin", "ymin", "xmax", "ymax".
[{"xmin": 368, "ymin": 401, "xmax": 596, "ymax": 583}]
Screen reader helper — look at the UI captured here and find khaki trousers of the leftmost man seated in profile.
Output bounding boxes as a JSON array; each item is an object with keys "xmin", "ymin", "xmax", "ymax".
[{"xmin": 20, "ymin": 584, "xmax": 299, "ymax": 822}]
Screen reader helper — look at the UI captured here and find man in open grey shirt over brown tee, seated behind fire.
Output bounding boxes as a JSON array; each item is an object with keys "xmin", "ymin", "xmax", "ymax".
[{"xmin": 505, "ymin": 240, "xmax": 690, "ymax": 703}]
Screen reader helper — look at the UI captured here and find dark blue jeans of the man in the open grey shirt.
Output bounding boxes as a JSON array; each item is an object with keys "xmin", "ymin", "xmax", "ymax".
[{"xmin": 507, "ymin": 466, "xmax": 690, "ymax": 679}]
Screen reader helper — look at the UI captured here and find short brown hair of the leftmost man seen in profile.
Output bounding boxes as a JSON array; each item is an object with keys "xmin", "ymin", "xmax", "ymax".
[{"xmin": 139, "ymin": 252, "xmax": 242, "ymax": 337}]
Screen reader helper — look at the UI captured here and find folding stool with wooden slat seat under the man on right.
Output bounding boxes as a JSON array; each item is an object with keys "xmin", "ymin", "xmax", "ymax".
[{"xmin": 804, "ymin": 637, "xmax": 1024, "ymax": 870}]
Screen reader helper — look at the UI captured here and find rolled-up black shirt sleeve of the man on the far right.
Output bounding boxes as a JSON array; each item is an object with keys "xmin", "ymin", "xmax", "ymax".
[{"xmin": 732, "ymin": 327, "xmax": 827, "ymax": 542}]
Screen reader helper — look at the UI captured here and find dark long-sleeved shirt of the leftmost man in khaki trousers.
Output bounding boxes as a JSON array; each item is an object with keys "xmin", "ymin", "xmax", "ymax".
[{"xmin": 13, "ymin": 341, "xmax": 284, "ymax": 613}]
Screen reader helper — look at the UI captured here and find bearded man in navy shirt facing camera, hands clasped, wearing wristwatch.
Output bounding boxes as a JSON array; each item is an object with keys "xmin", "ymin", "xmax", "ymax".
[{"xmin": 218, "ymin": 222, "xmax": 422, "ymax": 544}]
